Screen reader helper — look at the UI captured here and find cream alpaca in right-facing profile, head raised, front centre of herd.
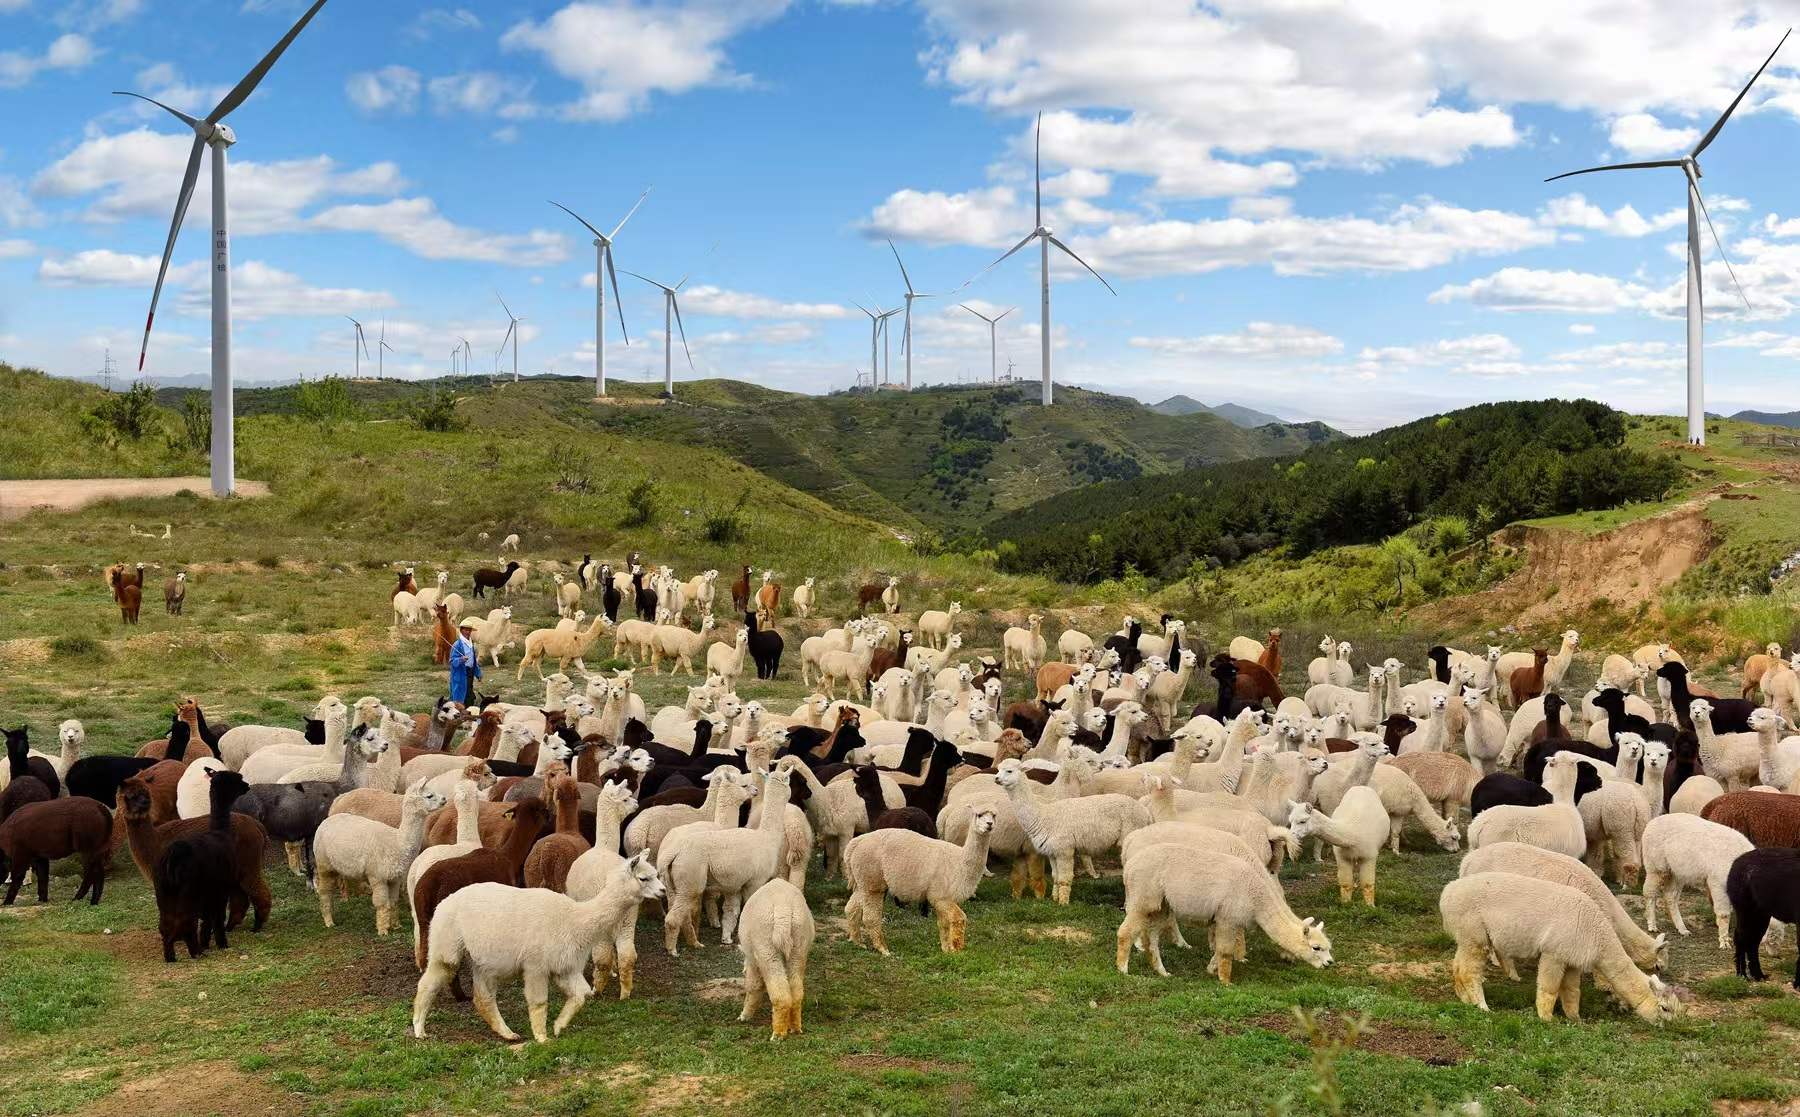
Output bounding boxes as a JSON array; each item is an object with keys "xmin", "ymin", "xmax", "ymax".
[{"xmin": 844, "ymin": 809, "xmax": 994, "ymax": 955}]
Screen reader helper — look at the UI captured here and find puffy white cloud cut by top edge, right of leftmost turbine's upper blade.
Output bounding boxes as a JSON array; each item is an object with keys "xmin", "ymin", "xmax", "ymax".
[{"xmin": 500, "ymin": 0, "xmax": 787, "ymax": 121}]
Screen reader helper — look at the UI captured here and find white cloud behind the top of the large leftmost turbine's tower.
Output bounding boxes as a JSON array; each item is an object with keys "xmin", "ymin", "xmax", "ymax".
[{"xmin": 31, "ymin": 128, "xmax": 405, "ymax": 236}]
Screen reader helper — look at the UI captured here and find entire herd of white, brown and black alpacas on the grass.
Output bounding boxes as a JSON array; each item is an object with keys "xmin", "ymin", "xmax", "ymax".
[{"xmin": 10, "ymin": 540, "xmax": 1800, "ymax": 1041}]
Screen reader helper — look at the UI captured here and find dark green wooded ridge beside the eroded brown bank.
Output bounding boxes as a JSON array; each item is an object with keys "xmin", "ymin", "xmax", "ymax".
[{"xmin": 986, "ymin": 399, "xmax": 1681, "ymax": 581}]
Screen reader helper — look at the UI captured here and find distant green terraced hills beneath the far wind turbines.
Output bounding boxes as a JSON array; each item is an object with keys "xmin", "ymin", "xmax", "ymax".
[{"xmin": 151, "ymin": 378, "xmax": 1336, "ymax": 536}]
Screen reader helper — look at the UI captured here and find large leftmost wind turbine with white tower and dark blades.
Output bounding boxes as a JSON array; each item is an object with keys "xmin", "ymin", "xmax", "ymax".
[{"xmin": 113, "ymin": 0, "xmax": 326, "ymax": 496}]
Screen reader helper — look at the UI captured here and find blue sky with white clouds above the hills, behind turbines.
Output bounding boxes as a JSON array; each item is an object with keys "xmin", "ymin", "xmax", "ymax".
[{"xmin": 0, "ymin": 0, "xmax": 1800, "ymax": 430}]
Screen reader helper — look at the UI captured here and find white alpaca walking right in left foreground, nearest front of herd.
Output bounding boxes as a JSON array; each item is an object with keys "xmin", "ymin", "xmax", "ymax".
[{"xmin": 412, "ymin": 854, "xmax": 662, "ymax": 1043}]
